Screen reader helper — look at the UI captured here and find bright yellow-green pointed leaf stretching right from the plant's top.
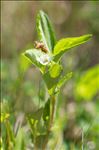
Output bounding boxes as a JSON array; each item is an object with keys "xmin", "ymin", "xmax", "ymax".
[{"xmin": 54, "ymin": 34, "xmax": 92, "ymax": 61}]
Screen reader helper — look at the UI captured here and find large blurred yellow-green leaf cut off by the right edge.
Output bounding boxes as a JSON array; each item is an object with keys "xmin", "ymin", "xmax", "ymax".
[{"xmin": 75, "ymin": 65, "xmax": 99, "ymax": 100}]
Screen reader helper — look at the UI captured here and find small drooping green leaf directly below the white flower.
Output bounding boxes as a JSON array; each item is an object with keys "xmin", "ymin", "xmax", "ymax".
[{"xmin": 43, "ymin": 63, "xmax": 62, "ymax": 95}]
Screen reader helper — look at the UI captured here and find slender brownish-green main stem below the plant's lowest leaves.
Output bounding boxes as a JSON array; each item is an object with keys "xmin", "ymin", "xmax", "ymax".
[{"xmin": 42, "ymin": 95, "xmax": 56, "ymax": 150}]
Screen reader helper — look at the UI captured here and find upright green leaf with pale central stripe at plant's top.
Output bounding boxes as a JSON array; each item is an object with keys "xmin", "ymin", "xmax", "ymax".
[{"xmin": 37, "ymin": 11, "xmax": 56, "ymax": 51}]
